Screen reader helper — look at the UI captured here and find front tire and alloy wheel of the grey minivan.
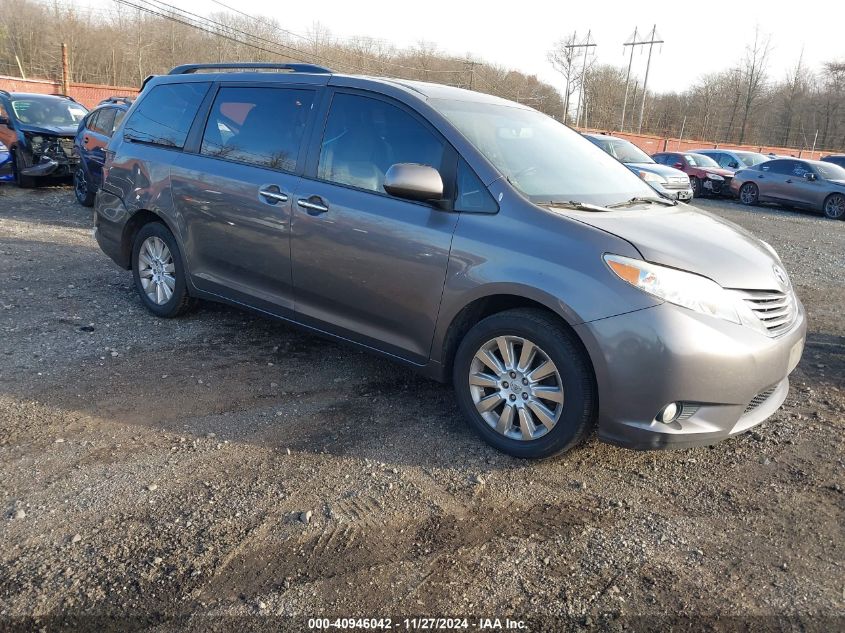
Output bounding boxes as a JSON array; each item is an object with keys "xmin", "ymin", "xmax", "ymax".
[{"xmin": 452, "ymin": 308, "xmax": 597, "ymax": 459}]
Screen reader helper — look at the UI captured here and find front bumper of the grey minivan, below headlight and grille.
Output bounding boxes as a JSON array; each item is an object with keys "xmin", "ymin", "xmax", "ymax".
[{"xmin": 575, "ymin": 300, "xmax": 807, "ymax": 449}]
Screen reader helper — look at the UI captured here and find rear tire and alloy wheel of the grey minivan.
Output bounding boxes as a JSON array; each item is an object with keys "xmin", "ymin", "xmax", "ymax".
[{"xmin": 132, "ymin": 222, "xmax": 194, "ymax": 319}]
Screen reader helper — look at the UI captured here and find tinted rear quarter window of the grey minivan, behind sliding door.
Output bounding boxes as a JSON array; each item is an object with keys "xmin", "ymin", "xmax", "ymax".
[{"xmin": 123, "ymin": 82, "xmax": 210, "ymax": 149}]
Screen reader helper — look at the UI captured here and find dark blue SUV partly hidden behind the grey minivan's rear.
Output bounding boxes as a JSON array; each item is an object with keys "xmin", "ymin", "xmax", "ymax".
[{"xmin": 73, "ymin": 97, "xmax": 132, "ymax": 207}]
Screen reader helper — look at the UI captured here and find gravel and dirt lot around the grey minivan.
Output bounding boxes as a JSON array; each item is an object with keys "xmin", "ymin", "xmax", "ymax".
[{"xmin": 0, "ymin": 187, "xmax": 845, "ymax": 631}]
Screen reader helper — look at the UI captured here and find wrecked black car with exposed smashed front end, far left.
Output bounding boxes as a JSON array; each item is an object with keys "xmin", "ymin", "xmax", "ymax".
[{"xmin": 0, "ymin": 90, "xmax": 88, "ymax": 187}]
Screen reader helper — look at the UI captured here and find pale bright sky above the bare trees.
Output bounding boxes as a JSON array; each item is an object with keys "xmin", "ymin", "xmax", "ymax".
[{"xmin": 87, "ymin": 0, "xmax": 845, "ymax": 92}]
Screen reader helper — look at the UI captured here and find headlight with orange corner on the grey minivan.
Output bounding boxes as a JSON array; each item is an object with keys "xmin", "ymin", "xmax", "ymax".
[{"xmin": 604, "ymin": 254, "xmax": 742, "ymax": 324}]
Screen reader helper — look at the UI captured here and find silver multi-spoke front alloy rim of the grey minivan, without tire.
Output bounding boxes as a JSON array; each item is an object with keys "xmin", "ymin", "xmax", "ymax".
[{"xmin": 468, "ymin": 336, "xmax": 564, "ymax": 441}]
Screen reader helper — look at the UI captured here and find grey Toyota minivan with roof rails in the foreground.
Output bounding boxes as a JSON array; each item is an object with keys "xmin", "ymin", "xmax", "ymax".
[{"xmin": 94, "ymin": 64, "xmax": 806, "ymax": 458}]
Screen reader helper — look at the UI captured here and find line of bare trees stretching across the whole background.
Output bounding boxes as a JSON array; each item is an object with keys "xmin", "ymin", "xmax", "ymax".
[{"xmin": 0, "ymin": 0, "xmax": 845, "ymax": 149}]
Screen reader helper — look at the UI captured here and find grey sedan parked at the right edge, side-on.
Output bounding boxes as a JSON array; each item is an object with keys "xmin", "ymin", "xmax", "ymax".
[{"xmin": 731, "ymin": 158, "xmax": 845, "ymax": 220}]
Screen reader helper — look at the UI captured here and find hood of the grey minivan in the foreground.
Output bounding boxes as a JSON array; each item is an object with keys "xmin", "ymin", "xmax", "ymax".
[{"xmin": 558, "ymin": 204, "xmax": 782, "ymax": 290}]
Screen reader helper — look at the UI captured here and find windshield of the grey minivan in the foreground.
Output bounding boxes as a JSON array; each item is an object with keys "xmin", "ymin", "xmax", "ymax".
[{"xmin": 429, "ymin": 99, "xmax": 657, "ymax": 205}]
